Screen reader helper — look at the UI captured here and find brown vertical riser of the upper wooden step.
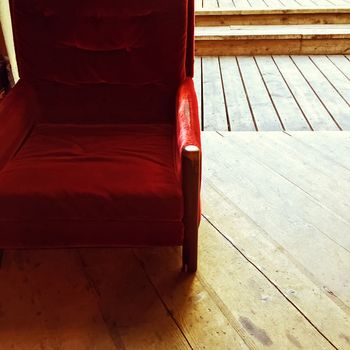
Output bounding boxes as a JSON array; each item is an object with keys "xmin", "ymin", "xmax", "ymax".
[{"xmin": 196, "ymin": 13, "xmax": 350, "ymax": 27}]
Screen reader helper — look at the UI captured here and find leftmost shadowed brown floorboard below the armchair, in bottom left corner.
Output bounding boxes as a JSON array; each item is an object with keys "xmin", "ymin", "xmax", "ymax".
[{"xmin": 0, "ymin": 250, "xmax": 117, "ymax": 350}]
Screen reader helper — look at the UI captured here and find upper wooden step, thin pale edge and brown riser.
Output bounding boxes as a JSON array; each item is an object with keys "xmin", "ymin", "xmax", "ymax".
[{"xmin": 196, "ymin": 5, "xmax": 350, "ymax": 27}]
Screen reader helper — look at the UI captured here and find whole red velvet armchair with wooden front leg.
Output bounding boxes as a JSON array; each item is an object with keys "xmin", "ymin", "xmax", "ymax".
[{"xmin": 0, "ymin": 0, "xmax": 201, "ymax": 271}]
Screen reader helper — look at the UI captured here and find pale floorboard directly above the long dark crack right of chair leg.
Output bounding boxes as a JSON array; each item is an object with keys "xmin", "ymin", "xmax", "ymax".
[{"xmin": 203, "ymin": 181, "xmax": 350, "ymax": 349}]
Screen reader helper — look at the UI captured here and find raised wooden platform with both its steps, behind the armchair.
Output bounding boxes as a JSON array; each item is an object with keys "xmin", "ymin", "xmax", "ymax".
[{"xmin": 196, "ymin": 0, "xmax": 350, "ymax": 56}]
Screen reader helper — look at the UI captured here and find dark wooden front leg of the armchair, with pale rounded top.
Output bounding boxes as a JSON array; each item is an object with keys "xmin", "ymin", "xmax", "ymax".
[{"xmin": 182, "ymin": 146, "xmax": 200, "ymax": 273}]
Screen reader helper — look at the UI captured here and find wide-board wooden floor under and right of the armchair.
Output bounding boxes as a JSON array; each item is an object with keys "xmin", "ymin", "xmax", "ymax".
[{"xmin": 0, "ymin": 132, "xmax": 350, "ymax": 350}]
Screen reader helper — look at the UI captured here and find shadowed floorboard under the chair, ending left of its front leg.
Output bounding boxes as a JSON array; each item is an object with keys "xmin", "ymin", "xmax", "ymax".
[{"xmin": 80, "ymin": 249, "xmax": 190, "ymax": 350}]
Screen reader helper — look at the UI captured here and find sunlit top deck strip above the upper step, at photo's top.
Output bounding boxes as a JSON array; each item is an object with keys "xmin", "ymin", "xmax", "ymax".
[{"xmin": 195, "ymin": 0, "xmax": 350, "ymax": 10}]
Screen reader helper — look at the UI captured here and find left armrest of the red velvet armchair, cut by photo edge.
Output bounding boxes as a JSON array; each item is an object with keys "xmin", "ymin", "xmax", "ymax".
[{"xmin": 0, "ymin": 81, "xmax": 38, "ymax": 170}]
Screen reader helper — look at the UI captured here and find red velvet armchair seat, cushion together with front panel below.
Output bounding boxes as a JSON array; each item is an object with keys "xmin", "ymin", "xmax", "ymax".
[{"xmin": 0, "ymin": 124, "xmax": 183, "ymax": 247}]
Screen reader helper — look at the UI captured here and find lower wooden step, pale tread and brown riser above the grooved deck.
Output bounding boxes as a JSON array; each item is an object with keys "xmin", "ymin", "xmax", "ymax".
[{"xmin": 195, "ymin": 24, "xmax": 350, "ymax": 56}]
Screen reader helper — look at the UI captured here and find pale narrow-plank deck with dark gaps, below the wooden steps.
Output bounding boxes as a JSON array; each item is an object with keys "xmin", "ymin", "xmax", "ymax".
[{"xmin": 195, "ymin": 55, "xmax": 350, "ymax": 131}]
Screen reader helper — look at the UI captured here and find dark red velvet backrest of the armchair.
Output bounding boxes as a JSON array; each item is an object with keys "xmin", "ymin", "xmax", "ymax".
[{"xmin": 10, "ymin": 0, "xmax": 194, "ymax": 123}]
